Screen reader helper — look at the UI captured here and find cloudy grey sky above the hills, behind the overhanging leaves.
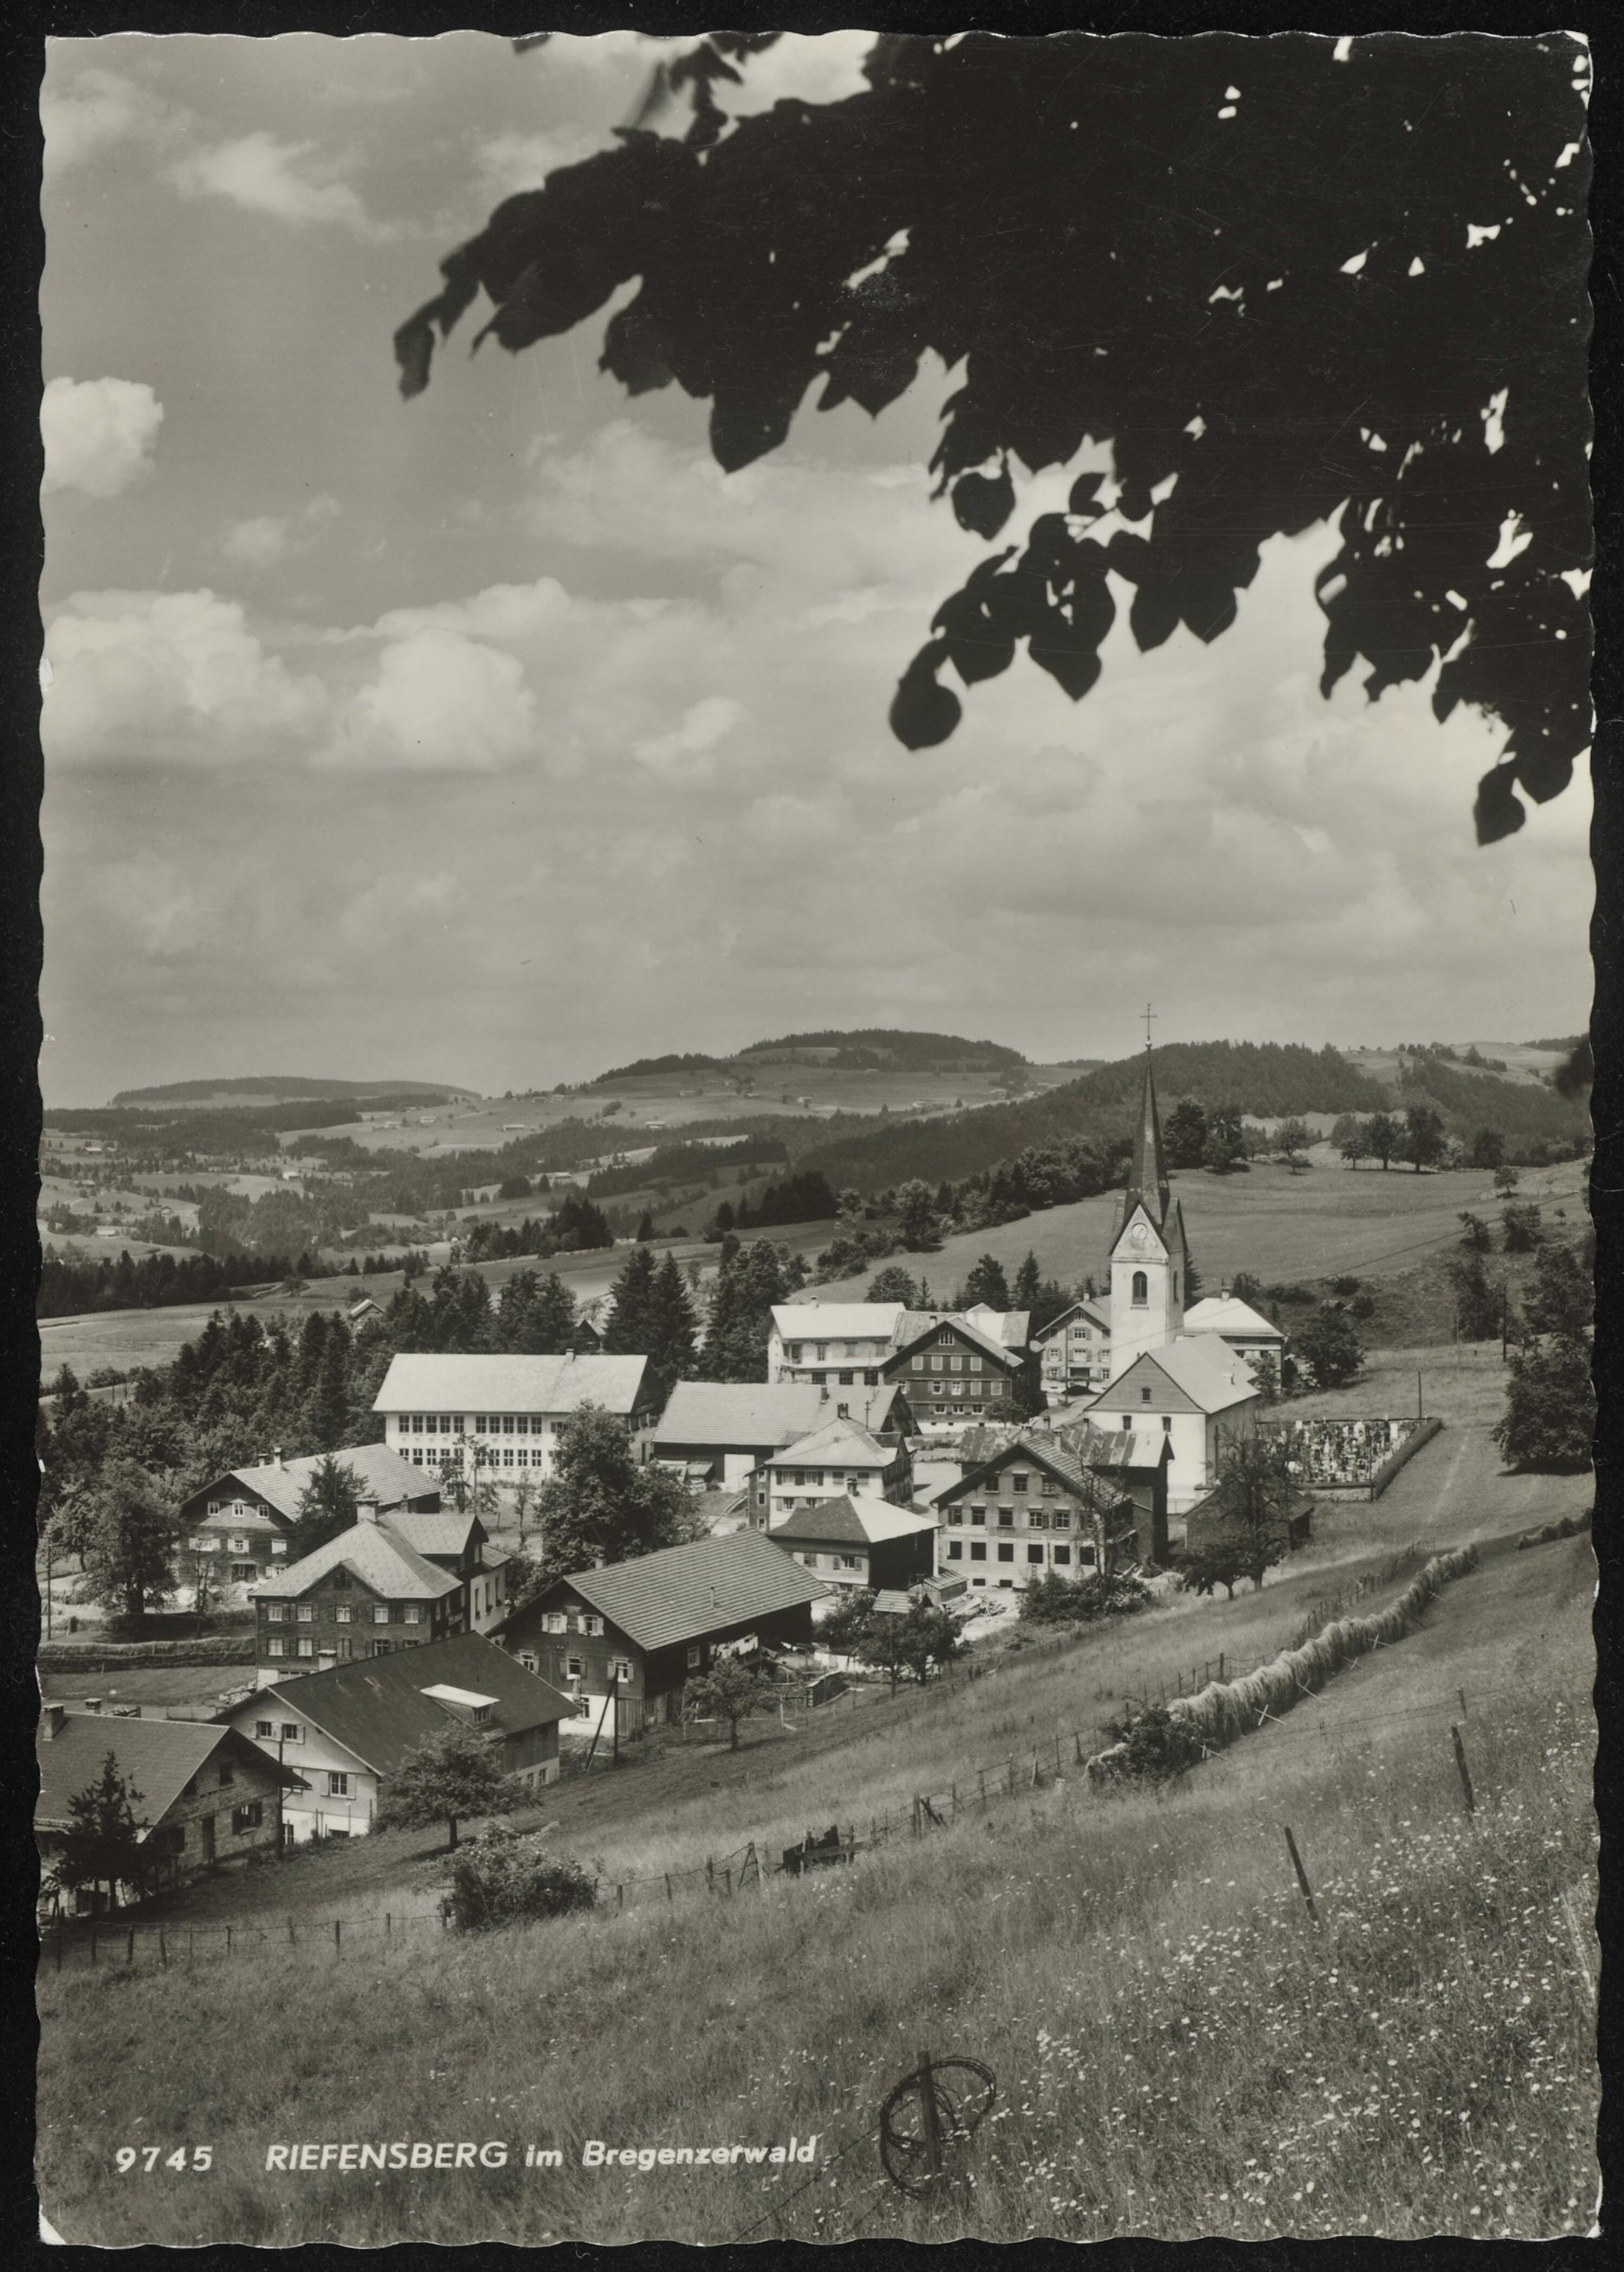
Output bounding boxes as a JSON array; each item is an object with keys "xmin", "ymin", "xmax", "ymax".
[{"xmin": 41, "ymin": 34, "xmax": 1592, "ymax": 1104}]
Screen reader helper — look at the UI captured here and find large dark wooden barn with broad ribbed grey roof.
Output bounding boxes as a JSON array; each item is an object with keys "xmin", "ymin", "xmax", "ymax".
[{"xmin": 493, "ymin": 1531, "xmax": 829, "ymax": 1738}]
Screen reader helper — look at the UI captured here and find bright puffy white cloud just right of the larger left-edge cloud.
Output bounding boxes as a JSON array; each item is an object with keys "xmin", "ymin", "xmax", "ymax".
[{"xmin": 316, "ymin": 627, "xmax": 536, "ymax": 773}]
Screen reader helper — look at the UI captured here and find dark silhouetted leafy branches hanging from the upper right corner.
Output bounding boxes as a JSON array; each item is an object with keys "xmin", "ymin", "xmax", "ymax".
[{"xmin": 395, "ymin": 32, "xmax": 1590, "ymax": 843}]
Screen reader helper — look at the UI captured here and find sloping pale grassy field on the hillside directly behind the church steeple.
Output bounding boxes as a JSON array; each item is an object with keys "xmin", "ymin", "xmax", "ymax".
[{"xmin": 797, "ymin": 1161, "xmax": 1586, "ymax": 1302}]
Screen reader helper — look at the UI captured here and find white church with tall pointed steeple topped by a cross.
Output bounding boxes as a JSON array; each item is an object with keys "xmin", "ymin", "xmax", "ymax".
[{"xmin": 1054, "ymin": 1047, "xmax": 1286, "ymax": 1516}]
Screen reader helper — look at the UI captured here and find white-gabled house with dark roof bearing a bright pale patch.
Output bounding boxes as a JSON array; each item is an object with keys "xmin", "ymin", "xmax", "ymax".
[{"xmin": 222, "ymin": 1634, "xmax": 575, "ymax": 1845}]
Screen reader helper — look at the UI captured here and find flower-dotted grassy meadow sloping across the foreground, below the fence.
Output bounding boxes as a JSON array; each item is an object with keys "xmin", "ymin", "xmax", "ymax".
[{"xmin": 38, "ymin": 1538, "xmax": 1597, "ymax": 2247}]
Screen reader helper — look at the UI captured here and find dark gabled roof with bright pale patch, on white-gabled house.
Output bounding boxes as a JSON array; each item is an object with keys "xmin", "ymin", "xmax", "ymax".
[{"xmin": 230, "ymin": 1634, "xmax": 575, "ymax": 1774}]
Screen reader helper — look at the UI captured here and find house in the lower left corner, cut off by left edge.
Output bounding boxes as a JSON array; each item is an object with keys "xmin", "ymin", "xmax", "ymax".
[{"xmin": 34, "ymin": 1704, "xmax": 295, "ymax": 1915}]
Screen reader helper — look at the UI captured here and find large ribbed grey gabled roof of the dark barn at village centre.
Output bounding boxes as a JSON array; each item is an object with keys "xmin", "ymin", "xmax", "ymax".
[{"xmin": 515, "ymin": 1531, "xmax": 829, "ymax": 1649}]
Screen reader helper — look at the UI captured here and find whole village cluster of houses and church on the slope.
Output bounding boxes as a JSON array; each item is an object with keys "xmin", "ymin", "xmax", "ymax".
[{"xmin": 36, "ymin": 1047, "xmax": 1571, "ymax": 1899}]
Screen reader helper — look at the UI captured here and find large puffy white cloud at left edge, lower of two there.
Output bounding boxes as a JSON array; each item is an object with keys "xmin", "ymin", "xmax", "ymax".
[{"xmin": 43, "ymin": 591, "xmax": 327, "ymax": 766}]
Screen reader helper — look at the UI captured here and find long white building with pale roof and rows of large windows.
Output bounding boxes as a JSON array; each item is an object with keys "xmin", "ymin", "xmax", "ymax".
[{"xmin": 372, "ymin": 1352, "xmax": 659, "ymax": 1484}]
